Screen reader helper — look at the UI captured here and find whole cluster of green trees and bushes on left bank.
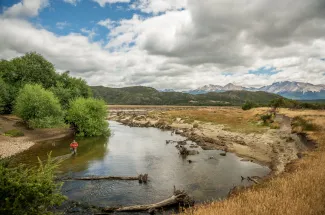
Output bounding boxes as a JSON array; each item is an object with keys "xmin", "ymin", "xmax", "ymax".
[{"xmin": 0, "ymin": 52, "xmax": 109, "ymax": 136}]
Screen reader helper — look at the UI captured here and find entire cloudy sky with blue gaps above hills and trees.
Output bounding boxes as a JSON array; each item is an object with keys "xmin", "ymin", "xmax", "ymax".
[{"xmin": 0, "ymin": 0, "xmax": 325, "ymax": 90}]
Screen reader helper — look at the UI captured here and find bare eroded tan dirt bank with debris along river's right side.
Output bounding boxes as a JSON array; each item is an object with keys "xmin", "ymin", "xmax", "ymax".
[{"xmin": 109, "ymin": 107, "xmax": 305, "ymax": 174}]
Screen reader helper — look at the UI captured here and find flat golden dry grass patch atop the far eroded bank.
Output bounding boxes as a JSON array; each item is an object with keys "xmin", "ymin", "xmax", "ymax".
[{"xmin": 165, "ymin": 107, "xmax": 266, "ymax": 133}]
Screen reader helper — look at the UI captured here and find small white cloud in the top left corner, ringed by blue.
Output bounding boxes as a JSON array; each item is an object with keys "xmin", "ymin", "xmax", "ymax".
[{"xmin": 3, "ymin": 0, "xmax": 49, "ymax": 17}]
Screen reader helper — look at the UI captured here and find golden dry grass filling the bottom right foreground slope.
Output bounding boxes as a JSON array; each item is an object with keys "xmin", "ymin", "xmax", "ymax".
[{"xmin": 184, "ymin": 109, "xmax": 325, "ymax": 215}]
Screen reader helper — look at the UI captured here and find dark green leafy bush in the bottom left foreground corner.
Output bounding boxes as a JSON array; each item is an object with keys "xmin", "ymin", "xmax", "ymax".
[{"xmin": 0, "ymin": 155, "xmax": 65, "ymax": 215}]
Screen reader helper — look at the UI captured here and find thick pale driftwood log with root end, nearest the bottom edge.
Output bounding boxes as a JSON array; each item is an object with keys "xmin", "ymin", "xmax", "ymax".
[{"xmin": 102, "ymin": 188, "xmax": 194, "ymax": 213}]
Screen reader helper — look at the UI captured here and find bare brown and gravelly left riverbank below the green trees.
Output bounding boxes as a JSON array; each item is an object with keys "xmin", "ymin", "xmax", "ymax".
[{"xmin": 0, "ymin": 115, "xmax": 73, "ymax": 158}]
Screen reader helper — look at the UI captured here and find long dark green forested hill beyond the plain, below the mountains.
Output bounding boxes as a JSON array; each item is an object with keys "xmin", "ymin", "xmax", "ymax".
[{"xmin": 91, "ymin": 86, "xmax": 281, "ymax": 106}]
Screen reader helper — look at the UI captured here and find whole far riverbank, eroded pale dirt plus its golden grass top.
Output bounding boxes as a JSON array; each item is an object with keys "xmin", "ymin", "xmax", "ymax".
[{"xmin": 109, "ymin": 106, "xmax": 305, "ymax": 175}]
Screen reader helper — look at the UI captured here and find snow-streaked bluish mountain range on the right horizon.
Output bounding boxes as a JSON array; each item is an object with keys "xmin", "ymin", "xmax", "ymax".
[{"xmin": 182, "ymin": 81, "xmax": 325, "ymax": 100}]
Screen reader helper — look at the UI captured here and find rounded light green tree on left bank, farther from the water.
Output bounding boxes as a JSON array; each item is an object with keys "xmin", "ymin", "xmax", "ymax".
[{"xmin": 14, "ymin": 84, "xmax": 64, "ymax": 128}]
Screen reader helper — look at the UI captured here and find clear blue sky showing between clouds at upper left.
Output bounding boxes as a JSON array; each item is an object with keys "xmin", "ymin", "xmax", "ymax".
[{"xmin": 2, "ymin": 0, "xmax": 135, "ymax": 41}]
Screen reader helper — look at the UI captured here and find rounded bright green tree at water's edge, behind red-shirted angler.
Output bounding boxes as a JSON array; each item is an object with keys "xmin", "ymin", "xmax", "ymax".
[{"xmin": 66, "ymin": 98, "xmax": 109, "ymax": 136}]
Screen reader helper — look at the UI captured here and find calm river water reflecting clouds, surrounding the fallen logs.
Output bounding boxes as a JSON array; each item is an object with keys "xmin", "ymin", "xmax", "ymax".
[{"xmin": 12, "ymin": 121, "xmax": 270, "ymax": 210}]
